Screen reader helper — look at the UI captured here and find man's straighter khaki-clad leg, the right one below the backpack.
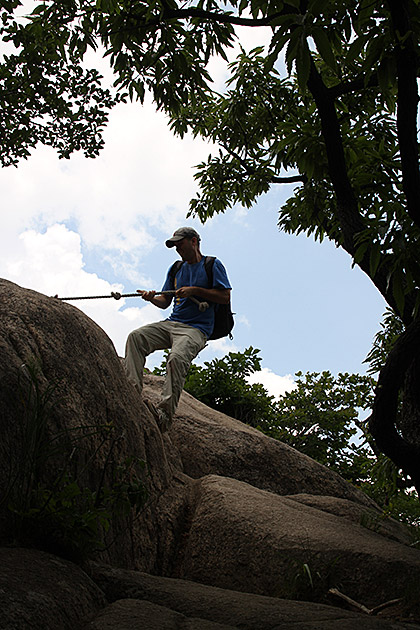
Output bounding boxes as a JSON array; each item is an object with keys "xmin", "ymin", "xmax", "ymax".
[{"xmin": 158, "ymin": 322, "xmax": 207, "ymax": 424}]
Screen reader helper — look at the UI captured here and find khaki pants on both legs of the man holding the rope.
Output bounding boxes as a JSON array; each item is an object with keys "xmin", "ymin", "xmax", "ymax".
[{"xmin": 125, "ymin": 320, "xmax": 207, "ymax": 420}]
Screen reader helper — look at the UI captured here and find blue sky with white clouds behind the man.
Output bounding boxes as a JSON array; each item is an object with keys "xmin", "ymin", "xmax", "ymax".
[{"xmin": 0, "ymin": 11, "xmax": 386, "ymax": 396}]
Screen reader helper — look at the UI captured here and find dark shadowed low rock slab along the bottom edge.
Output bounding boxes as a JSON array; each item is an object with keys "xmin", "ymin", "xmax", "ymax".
[{"xmin": 89, "ymin": 564, "xmax": 414, "ymax": 630}]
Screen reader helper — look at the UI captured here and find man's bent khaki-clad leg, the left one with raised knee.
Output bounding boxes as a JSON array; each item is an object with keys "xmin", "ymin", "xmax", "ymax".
[{"xmin": 124, "ymin": 321, "xmax": 171, "ymax": 393}]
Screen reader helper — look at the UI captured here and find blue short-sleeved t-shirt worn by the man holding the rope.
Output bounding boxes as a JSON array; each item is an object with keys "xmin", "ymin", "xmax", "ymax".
[{"xmin": 162, "ymin": 256, "xmax": 231, "ymax": 338}]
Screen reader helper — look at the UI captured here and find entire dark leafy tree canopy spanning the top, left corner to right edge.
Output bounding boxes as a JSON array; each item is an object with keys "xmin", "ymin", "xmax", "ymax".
[{"xmin": 4, "ymin": 0, "xmax": 420, "ymax": 324}]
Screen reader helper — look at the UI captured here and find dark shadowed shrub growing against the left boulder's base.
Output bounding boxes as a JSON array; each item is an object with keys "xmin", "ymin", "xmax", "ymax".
[{"xmin": 0, "ymin": 364, "xmax": 146, "ymax": 562}]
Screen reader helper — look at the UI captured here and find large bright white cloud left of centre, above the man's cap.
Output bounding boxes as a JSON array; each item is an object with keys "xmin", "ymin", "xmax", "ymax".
[{"xmin": 0, "ymin": 97, "xmax": 208, "ymax": 244}]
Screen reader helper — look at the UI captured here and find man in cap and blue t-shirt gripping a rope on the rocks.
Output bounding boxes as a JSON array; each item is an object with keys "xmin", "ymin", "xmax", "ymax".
[{"xmin": 125, "ymin": 227, "xmax": 231, "ymax": 432}]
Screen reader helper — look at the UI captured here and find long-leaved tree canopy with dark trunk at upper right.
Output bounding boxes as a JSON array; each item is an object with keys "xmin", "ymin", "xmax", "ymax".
[{"xmin": 172, "ymin": 1, "xmax": 420, "ymax": 323}]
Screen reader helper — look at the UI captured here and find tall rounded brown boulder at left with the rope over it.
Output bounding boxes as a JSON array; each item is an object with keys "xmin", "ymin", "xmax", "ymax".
[{"xmin": 0, "ymin": 280, "xmax": 173, "ymax": 570}]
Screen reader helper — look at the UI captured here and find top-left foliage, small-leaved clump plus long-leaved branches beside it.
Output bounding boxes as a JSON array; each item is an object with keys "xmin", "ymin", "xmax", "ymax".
[{"xmin": 0, "ymin": 0, "xmax": 233, "ymax": 166}]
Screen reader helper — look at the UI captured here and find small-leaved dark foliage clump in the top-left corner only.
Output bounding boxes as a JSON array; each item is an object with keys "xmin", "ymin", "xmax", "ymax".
[{"xmin": 0, "ymin": 2, "xmax": 124, "ymax": 166}]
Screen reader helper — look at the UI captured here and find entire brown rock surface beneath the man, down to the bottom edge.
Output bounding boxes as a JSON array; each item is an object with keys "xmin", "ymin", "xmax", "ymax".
[{"xmin": 0, "ymin": 280, "xmax": 420, "ymax": 630}]
